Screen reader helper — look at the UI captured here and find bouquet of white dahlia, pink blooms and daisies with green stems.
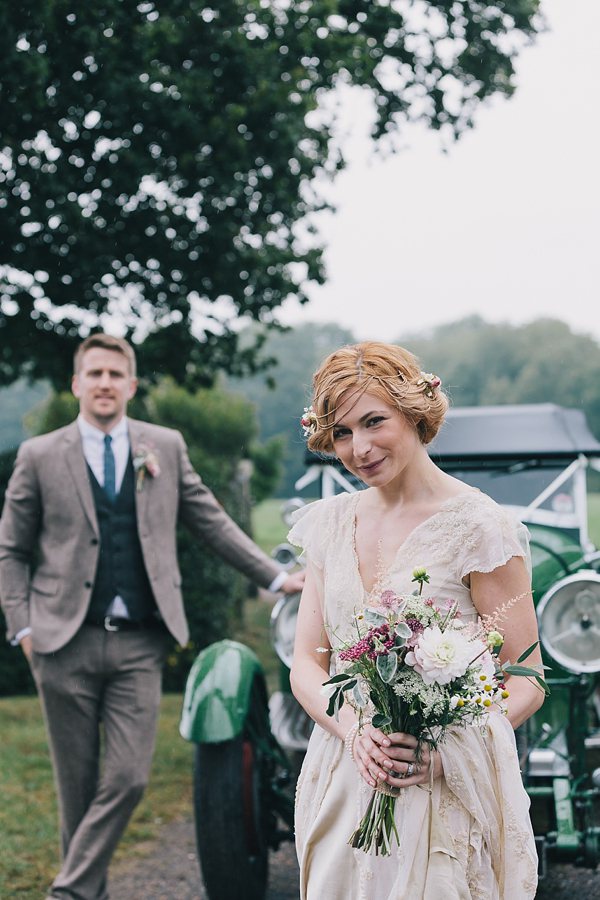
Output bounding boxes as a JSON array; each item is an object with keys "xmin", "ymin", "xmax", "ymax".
[{"xmin": 322, "ymin": 567, "xmax": 547, "ymax": 855}]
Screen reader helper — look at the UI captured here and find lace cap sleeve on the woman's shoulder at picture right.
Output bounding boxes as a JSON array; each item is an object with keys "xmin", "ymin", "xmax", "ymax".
[{"xmin": 458, "ymin": 494, "xmax": 531, "ymax": 581}]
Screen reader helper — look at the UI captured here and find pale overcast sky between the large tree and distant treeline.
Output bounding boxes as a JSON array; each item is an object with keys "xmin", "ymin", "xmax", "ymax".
[{"xmin": 279, "ymin": 0, "xmax": 600, "ymax": 341}]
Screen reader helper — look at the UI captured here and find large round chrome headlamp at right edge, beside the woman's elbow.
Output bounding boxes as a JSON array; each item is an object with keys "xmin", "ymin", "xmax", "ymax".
[{"xmin": 537, "ymin": 570, "xmax": 600, "ymax": 674}]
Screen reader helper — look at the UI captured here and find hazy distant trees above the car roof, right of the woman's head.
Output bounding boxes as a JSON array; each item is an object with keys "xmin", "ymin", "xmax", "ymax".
[{"xmin": 399, "ymin": 316, "xmax": 600, "ymax": 436}]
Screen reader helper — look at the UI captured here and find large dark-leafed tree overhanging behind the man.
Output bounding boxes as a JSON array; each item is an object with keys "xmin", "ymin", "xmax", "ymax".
[{"xmin": 0, "ymin": 0, "xmax": 538, "ymax": 388}]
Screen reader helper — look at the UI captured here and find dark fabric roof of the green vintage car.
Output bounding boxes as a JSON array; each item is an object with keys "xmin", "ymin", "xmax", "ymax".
[{"xmin": 427, "ymin": 403, "xmax": 600, "ymax": 462}]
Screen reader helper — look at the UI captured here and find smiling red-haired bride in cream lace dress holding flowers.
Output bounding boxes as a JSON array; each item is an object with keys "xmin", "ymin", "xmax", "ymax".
[{"xmin": 289, "ymin": 341, "xmax": 543, "ymax": 900}]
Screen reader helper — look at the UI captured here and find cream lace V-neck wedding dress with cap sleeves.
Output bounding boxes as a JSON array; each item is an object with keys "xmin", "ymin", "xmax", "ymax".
[{"xmin": 289, "ymin": 490, "xmax": 537, "ymax": 900}]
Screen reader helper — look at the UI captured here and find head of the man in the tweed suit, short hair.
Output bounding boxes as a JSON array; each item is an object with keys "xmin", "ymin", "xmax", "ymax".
[{"xmin": 73, "ymin": 347, "xmax": 137, "ymax": 432}]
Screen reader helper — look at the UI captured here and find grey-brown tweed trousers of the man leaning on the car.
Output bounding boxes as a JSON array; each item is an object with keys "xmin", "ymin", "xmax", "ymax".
[{"xmin": 32, "ymin": 625, "xmax": 167, "ymax": 900}]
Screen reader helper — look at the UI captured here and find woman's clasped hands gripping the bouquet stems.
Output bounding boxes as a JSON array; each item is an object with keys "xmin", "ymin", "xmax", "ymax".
[{"xmin": 353, "ymin": 725, "xmax": 444, "ymax": 787}]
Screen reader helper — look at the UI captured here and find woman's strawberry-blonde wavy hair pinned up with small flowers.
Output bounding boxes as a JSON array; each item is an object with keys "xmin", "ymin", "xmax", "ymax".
[{"xmin": 308, "ymin": 341, "xmax": 449, "ymax": 453}]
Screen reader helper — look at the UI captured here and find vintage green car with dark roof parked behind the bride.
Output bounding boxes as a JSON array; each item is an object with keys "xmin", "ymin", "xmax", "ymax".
[{"xmin": 181, "ymin": 404, "xmax": 600, "ymax": 900}]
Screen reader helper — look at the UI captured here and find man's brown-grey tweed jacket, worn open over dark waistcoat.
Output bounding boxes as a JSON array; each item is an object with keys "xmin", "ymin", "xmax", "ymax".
[{"xmin": 0, "ymin": 419, "xmax": 280, "ymax": 653}]
